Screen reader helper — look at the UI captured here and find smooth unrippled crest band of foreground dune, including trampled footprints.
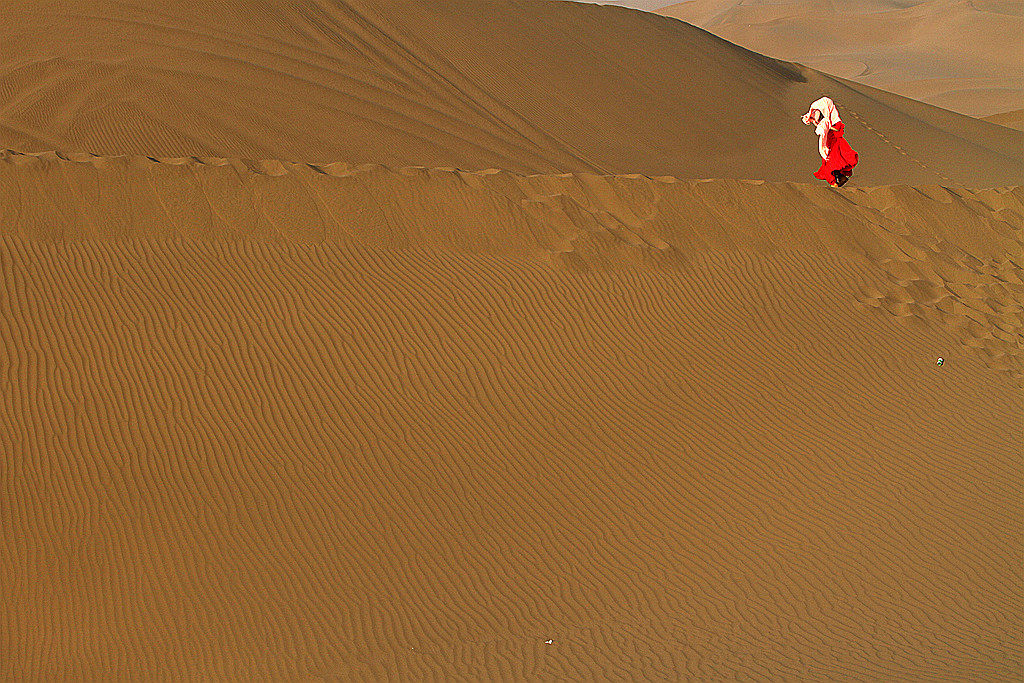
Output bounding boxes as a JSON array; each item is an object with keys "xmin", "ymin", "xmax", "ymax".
[{"xmin": 0, "ymin": 151, "xmax": 1024, "ymax": 377}]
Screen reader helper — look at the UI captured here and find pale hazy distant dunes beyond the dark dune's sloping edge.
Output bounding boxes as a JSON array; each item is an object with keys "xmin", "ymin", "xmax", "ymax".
[{"xmin": 656, "ymin": 0, "xmax": 1024, "ymax": 117}]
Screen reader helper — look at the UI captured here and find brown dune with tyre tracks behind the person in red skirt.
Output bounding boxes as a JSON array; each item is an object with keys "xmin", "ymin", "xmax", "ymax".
[{"xmin": 0, "ymin": 0, "xmax": 1024, "ymax": 186}]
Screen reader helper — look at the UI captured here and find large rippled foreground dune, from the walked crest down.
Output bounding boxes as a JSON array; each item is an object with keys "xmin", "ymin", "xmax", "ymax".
[{"xmin": 0, "ymin": 153, "xmax": 1024, "ymax": 680}]
